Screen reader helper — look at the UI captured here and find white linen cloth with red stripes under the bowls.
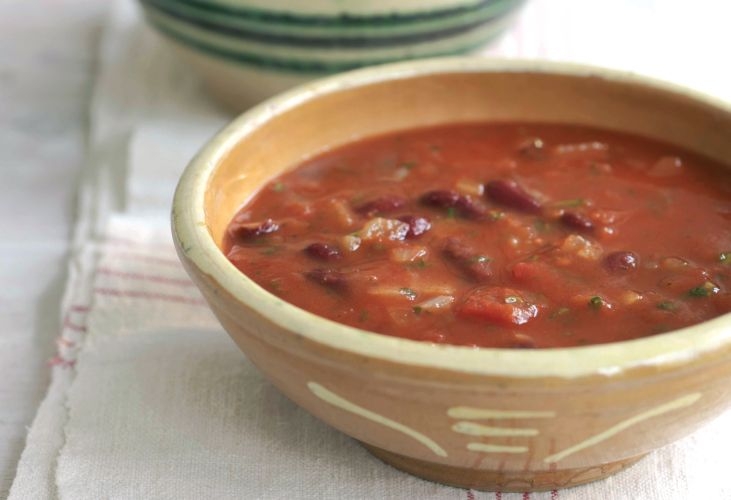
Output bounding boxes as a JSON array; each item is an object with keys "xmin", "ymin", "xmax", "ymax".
[{"xmin": 10, "ymin": 0, "xmax": 731, "ymax": 500}]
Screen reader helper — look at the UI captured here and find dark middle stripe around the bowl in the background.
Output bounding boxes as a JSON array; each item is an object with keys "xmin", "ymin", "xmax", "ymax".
[{"xmin": 141, "ymin": 0, "xmax": 524, "ymax": 42}]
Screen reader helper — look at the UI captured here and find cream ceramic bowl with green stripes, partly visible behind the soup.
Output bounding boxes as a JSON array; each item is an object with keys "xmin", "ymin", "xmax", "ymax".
[{"xmin": 141, "ymin": 0, "xmax": 523, "ymax": 109}]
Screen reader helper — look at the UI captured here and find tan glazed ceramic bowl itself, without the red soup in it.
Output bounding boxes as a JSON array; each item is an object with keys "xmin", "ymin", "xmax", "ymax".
[{"xmin": 173, "ymin": 59, "xmax": 731, "ymax": 491}]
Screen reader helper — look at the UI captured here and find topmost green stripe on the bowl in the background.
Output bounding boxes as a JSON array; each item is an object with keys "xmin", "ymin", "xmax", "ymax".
[{"xmin": 172, "ymin": 0, "xmax": 516, "ymax": 27}]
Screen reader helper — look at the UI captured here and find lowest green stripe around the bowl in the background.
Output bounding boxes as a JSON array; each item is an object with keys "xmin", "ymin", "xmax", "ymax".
[{"xmin": 148, "ymin": 11, "xmax": 508, "ymax": 76}]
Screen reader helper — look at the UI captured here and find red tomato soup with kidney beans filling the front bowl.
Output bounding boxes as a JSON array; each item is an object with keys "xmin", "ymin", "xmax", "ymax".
[{"xmin": 224, "ymin": 123, "xmax": 731, "ymax": 348}]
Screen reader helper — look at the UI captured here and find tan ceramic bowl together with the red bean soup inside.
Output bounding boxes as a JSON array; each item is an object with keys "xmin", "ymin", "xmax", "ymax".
[{"xmin": 172, "ymin": 58, "xmax": 731, "ymax": 491}]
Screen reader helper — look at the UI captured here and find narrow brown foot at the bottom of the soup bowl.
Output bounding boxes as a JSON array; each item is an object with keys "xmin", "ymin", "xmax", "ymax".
[{"xmin": 361, "ymin": 443, "xmax": 645, "ymax": 493}]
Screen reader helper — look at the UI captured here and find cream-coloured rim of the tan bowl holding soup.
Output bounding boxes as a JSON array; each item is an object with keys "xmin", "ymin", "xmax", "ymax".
[{"xmin": 172, "ymin": 57, "xmax": 731, "ymax": 379}]
